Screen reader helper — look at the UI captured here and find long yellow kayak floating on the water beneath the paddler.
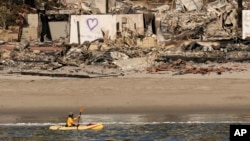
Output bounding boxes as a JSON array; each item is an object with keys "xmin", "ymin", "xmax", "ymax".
[{"xmin": 49, "ymin": 123, "xmax": 104, "ymax": 130}]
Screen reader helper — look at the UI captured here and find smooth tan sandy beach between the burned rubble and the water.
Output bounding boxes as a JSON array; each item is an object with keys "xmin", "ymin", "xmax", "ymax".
[{"xmin": 0, "ymin": 66, "xmax": 250, "ymax": 122}]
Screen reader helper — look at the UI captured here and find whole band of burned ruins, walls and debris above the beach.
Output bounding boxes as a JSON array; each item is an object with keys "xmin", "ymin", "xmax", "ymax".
[{"xmin": 0, "ymin": 0, "xmax": 250, "ymax": 78}]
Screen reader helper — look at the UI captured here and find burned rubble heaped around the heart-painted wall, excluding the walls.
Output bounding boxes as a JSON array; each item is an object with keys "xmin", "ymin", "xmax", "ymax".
[{"xmin": 0, "ymin": 0, "xmax": 250, "ymax": 78}]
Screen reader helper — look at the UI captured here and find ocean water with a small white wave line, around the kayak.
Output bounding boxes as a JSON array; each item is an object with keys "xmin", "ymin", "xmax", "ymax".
[{"xmin": 0, "ymin": 114, "xmax": 250, "ymax": 141}]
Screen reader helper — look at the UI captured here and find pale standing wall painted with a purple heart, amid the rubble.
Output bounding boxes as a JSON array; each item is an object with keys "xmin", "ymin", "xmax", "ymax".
[{"xmin": 70, "ymin": 14, "xmax": 144, "ymax": 43}]
